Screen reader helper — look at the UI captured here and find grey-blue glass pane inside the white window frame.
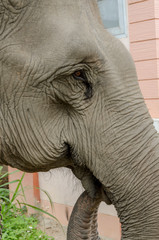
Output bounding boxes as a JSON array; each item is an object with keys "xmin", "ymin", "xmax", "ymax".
[{"xmin": 98, "ymin": 0, "xmax": 119, "ymax": 28}]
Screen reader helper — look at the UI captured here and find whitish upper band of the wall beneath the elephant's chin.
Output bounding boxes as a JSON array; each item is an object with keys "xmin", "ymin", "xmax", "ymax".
[{"xmin": 39, "ymin": 168, "xmax": 117, "ymax": 216}]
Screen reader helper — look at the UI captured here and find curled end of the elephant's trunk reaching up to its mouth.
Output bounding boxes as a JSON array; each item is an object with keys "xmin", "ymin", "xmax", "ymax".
[{"xmin": 67, "ymin": 191, "xmax": 101, "ymax": 240}]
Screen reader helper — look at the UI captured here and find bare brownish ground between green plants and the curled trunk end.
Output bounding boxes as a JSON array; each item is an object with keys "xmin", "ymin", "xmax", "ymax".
[{"xmin": 39, "ymin": 217, "xmax": 111, "ymax": 240}]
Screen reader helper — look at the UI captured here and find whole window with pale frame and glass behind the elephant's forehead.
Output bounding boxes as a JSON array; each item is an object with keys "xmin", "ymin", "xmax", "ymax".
[{"xmin": 98, "ymin": 0, "xmax": 127, "ymax": 38}]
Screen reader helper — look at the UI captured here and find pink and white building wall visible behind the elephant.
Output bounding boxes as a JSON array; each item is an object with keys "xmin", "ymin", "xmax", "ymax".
[{"xmin": 8, "ymin": 0, "xmax": 159, "ymax": 240}]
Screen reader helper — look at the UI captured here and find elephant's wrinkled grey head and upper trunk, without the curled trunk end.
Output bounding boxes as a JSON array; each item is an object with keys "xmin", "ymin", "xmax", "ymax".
[{"xmin": 0, "ymin": 0, "xmax": 159, "ymax": 240}]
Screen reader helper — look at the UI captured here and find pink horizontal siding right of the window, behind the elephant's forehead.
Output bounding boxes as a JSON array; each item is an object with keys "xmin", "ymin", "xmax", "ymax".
[{"xmin": 128, "ymin": 0, "xmax": 159, "ymax": 118}]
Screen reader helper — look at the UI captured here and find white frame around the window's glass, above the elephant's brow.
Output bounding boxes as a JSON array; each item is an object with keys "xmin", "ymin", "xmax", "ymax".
[{"xmin": 97, "ymin": 0, "xmax": 128, "ymax": 38}]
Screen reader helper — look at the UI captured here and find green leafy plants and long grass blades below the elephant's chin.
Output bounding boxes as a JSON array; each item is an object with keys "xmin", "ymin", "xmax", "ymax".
[{"xmin": 0, "ymin": 167, "xmax": 56, "ymax": 240}]
